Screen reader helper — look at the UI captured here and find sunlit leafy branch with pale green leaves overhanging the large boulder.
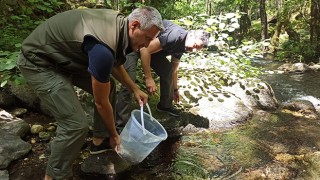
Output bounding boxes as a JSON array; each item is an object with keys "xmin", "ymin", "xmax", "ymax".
[{"xmin": 176, "ymin": 13, "xmax": 262, "ymax": 92}]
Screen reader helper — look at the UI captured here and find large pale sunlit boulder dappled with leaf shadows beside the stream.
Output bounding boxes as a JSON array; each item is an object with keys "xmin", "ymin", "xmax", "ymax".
[{"xmin": 179, "ymin": 64, "xmax": 278, "ymax": 130}]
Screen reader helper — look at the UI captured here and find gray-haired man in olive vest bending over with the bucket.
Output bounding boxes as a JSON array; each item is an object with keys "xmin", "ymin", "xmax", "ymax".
[{"xmin": 17, "ymin": 7, "xmax": 163, "ymax": 180}]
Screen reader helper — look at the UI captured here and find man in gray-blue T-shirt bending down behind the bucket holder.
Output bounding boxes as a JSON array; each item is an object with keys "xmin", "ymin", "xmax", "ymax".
[{"xmin": 116, "ymin": 20, "xmax": 208, "ymax": 122}]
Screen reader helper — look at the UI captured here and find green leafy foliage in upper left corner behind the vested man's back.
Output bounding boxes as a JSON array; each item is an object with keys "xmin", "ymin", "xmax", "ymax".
[{"xmin": 0, "ymin": 0, "xmax": 64, "ymax": 87}]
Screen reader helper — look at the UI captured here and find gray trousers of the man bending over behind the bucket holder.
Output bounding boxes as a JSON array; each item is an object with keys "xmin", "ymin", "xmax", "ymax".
[{"xmin": 116, "ymin": 51, "xmax": 173, "ymax": 123}]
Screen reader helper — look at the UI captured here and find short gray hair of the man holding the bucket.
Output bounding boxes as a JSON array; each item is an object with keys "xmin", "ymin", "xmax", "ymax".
[{"xmin": 128, "ymin": 6, "xmax": 164, "ymax": 31}]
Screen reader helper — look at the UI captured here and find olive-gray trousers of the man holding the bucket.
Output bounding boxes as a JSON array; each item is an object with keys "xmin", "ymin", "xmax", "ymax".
[{"xmin": 17, "ymin": 54, "xmax": 115, "ymax": 180}]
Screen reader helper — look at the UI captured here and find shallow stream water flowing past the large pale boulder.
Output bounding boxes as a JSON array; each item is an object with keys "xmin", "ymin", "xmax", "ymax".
[{"xmin": 122, "ymin": 60, "xmax": 320, "ymax": 179}]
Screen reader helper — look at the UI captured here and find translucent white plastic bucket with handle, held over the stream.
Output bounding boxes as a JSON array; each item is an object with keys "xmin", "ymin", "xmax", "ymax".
[{"xmin": 119, "ymin": 104, "xmax": 168, "ymax": 164}]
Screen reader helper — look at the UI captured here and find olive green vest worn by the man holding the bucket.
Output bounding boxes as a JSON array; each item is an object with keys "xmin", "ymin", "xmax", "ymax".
[{"xmin": 22, "ymin": 9, "xmax": 129, "ymax": 73}]
